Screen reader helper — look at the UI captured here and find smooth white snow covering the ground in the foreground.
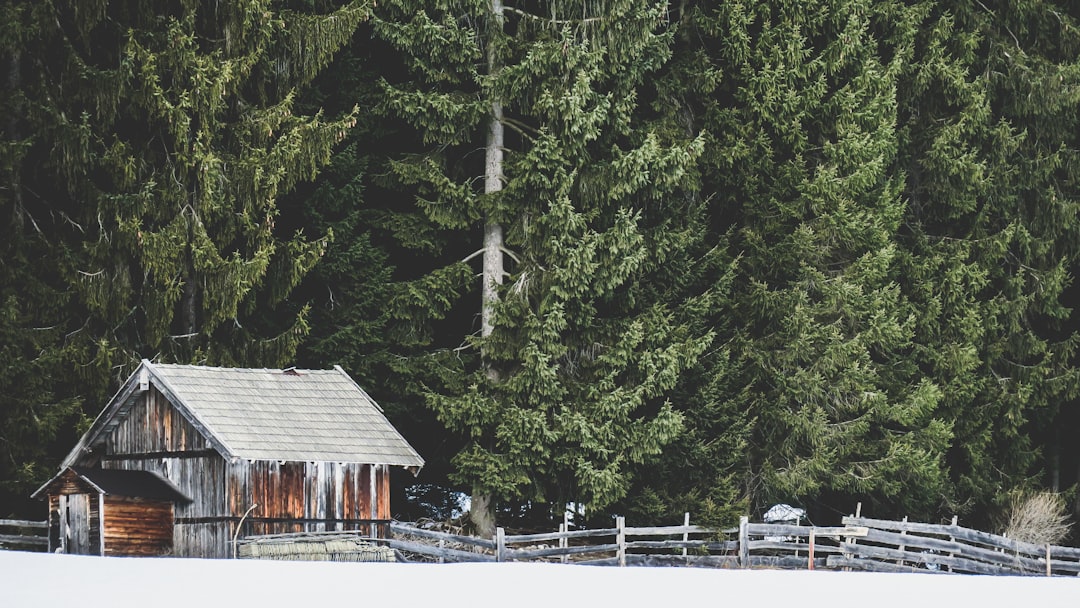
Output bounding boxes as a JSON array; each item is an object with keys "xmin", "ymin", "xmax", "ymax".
[{"xmin": 0, "ymin": 551, "xmax": 1080, "ymax": 608}]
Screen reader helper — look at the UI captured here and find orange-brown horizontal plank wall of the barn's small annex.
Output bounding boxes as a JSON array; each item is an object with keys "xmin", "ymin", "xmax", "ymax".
[{"xmin": 105, "ymin": 497, "xmax": 173, "ymax": 556}]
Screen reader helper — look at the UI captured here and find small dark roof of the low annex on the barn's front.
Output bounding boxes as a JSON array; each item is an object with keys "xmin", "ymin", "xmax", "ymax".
[{"xmin": 33, "ymin": 467, "xmax": 191, "ymax": 502}]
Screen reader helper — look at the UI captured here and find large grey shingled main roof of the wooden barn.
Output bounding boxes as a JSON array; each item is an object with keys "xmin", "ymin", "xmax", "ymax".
[{"xmin": 62, "ymin": 361, "xmax": 423, "ymax": 470}]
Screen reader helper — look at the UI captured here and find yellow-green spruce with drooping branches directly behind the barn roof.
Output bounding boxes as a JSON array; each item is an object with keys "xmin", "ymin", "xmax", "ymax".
[{"xmin": 11, "ymin": 2, "xmax": 367, "ymax": 374}]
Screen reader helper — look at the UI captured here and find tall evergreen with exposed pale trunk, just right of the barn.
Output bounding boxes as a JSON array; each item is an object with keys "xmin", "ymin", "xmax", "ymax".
[{"xmin": 376, "ymin": 1, "xmax": 707, "ymax": 530}]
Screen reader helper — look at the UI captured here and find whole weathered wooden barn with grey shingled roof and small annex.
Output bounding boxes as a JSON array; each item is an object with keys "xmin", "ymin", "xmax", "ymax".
[{"xmin": 33, "ymin": 361, "xmax": 423, "ymax": 557}]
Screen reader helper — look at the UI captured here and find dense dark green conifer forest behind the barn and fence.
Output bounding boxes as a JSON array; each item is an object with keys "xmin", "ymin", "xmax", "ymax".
[{"xmin": 0, "ymin": 0, "xmax": 1080, "ymax": 535}]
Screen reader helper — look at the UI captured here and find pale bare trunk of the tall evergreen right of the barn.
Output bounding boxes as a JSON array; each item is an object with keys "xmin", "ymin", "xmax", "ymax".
[{"xmin": 469, "ymin": 0, "xmax": 503, "ymax": 537}]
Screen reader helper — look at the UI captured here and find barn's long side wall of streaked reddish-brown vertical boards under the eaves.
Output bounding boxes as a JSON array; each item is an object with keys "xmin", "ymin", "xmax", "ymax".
[{"xmin": 227, "ymin": 460, "xmax": 390, "ymax": 536}]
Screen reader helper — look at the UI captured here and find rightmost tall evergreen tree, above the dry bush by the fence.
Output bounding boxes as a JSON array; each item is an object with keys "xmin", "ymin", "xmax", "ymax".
[{"xmin": 897, "ymin": 1, "xmax": 1080, "ymax": 518}]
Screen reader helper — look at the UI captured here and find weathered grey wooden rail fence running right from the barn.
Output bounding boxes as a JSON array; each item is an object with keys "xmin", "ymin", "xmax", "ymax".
[{"xmin": 236, "ymin": 516, "xmax": 1080, "ymax": 576}]
